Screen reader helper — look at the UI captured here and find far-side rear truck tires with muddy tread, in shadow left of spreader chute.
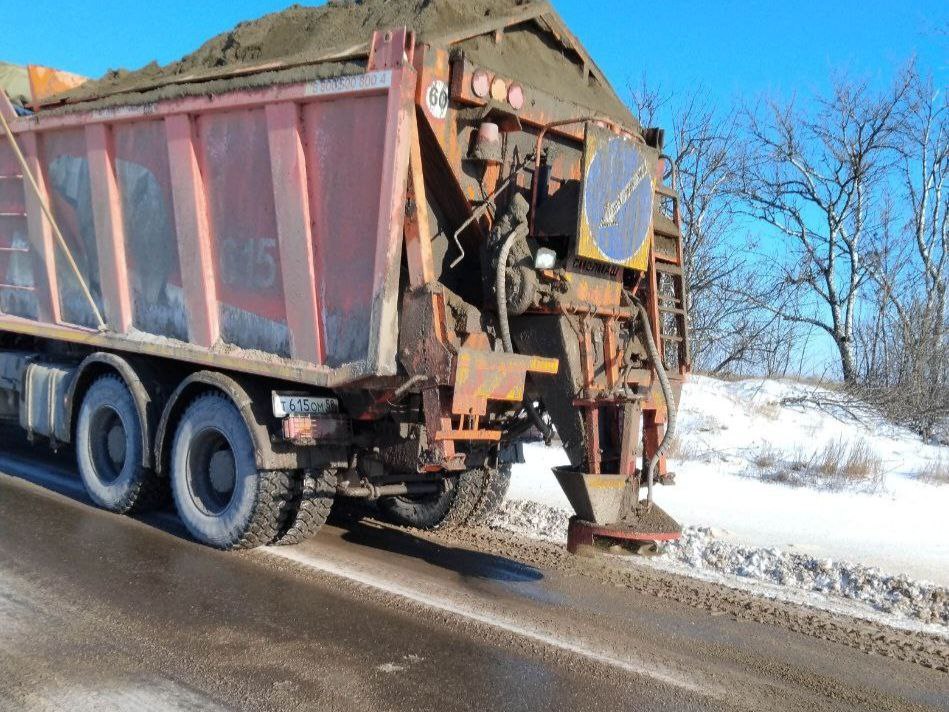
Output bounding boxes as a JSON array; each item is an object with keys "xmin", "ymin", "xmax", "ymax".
[{"xmin": 379, "ymin": 467, "xmax": 511, "ymax": 530}]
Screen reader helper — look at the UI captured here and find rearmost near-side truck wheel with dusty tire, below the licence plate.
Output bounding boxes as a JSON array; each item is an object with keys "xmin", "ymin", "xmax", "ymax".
[{"xmin": 171, "ymin": 393, "xmax": 290, "ymax": 549}]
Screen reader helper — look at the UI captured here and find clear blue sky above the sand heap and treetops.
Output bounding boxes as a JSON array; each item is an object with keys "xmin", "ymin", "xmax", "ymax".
[{"xmin": 0, "ymin": 0, "xmax": 949, "ymax": 101}]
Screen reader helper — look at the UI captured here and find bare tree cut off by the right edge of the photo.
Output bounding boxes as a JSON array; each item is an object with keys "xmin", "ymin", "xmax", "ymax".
[{"xmin": 862, "ymin": 69, "xmax": 949, "ymax": 431}]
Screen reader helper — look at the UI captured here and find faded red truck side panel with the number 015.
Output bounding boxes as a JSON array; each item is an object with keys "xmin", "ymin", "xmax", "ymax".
[{"xmin": 197, "ymin": 108, "xmax": 290, "ymax": 356}]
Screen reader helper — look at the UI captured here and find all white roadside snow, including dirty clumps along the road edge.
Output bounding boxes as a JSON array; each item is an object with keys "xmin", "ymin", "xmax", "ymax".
[{"xmin": 496, "ymin": 376, "xmax": 949, "ymax": 626}]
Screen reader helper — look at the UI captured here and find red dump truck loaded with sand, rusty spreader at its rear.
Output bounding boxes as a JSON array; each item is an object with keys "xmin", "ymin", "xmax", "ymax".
[{"xmin": 0, "ymin": 0, "xmax": 689, "ymax": 550}]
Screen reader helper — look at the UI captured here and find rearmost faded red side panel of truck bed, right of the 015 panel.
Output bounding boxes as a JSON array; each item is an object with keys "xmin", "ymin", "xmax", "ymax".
[{"xmin": 303, "ymin": 95, "xmax": 386, "ymax": 366}]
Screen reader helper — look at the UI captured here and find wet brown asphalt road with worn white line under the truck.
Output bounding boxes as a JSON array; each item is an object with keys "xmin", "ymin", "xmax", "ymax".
[{"xmin": 0, "ymin": 431, "xmax": 949, "ymax": 712}]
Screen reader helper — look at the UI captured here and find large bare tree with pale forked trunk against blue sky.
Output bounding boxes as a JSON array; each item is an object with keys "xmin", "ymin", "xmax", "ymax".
[{"xmin": 736, "ymin": 71, "xmax": 909, "ymax": 383}]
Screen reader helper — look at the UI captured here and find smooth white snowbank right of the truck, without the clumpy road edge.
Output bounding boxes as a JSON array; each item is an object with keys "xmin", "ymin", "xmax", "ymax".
[{"xmin": 657, "ymin": 376, "xmax": 949, "ymax": 587}]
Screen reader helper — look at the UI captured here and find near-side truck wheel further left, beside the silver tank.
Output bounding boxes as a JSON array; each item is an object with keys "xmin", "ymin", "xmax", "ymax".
[{"xmin": 76, "ymin": 376, "xmax": 163, "ymax": 514}]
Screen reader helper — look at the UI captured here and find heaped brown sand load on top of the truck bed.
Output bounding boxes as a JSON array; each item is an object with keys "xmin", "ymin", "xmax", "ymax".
[{"xmin": 50, "ymin": 0, "xmax": 635, "ymax": 125}]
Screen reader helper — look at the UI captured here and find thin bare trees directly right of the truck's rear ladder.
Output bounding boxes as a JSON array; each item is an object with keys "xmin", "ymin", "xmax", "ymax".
[{"xmin": 630, "ymin": 78, "xmax": 789, "ymax": 373}]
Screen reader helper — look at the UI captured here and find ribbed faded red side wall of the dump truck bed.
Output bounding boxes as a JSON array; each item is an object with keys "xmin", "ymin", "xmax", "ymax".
[{"xmin": 0, "ymin": 48, "xmax": 415, "ymax": 386}]
